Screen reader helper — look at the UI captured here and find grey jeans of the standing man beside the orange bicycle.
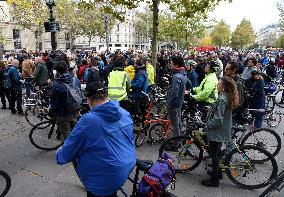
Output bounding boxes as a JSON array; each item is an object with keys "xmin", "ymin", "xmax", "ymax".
[{"xmin": 168, "ymin": 108, "xmax": 181, "ymax": 137}]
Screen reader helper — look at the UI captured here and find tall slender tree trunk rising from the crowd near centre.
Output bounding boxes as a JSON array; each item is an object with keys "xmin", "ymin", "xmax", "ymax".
[{"xmin": 152, "ymin": 0, "xmax": 160, "ymax": 81}]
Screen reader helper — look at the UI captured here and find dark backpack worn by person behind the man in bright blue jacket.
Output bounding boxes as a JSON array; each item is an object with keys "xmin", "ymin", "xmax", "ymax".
[{"xmin": 63, "ymin": 77, "xmax": 83, "ymax": 113}]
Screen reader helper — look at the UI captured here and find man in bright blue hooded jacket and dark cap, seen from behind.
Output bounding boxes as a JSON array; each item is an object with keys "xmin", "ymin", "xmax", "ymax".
[{"xmin": 56, "ymin": 82, "xmax": 136, "ymax": 197}]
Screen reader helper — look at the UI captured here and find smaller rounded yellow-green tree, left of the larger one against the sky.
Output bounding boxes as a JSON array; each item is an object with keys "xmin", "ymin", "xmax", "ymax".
[{"xmin": 211, "ymin": 20, "xmax": 231, "ymax": 47}]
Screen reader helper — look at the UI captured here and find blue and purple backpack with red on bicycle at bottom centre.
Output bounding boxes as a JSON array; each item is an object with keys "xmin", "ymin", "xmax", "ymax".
[{"xmin": 138, "ymin": 153, "xmax": 176, "ymax": 197}]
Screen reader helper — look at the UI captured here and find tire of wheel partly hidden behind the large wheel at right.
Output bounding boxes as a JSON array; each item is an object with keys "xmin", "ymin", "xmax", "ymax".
[{"xmin": 240, "ymin": 128, "xmax": 281, "ymax": 162}]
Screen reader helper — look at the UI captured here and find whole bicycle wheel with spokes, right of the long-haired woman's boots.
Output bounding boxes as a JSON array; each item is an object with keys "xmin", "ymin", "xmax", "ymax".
[{"xmin": 224, "ymin": 145, "xmax": 278, "ymax": 189}]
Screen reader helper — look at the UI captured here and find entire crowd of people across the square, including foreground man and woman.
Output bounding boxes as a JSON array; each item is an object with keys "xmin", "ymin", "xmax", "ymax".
[{"xmin": 0, "ymin": 49, "xmax": 284, "ymax": 196}]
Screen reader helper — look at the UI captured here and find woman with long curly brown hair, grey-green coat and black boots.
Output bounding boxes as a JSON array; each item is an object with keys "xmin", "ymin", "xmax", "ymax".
[{"xmin": 201, "ymin": 76, "xmax": 239, "ymax": 187}]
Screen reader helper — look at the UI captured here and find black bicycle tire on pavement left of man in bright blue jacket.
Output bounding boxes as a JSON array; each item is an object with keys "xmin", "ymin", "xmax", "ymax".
[{"xmin": 29, "ymin": 121, "xmax": 64, "ymax": 151}]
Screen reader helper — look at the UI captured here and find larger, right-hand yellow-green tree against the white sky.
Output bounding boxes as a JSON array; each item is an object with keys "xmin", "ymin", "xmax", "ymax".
[{"xmin": 231, "ymin": 18, "xmax": 256, "ymax": 49}]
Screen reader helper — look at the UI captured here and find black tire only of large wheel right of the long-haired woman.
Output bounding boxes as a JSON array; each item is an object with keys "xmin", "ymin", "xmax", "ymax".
[{"xmin": 224, "ymin": 145, "xmax": 278, "ymax": 189}]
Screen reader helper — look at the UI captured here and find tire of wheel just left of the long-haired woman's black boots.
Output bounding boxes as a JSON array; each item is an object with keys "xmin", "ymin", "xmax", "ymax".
[{"xmin": 159, "ymin": 136, "xmax": 203, "ymax": 172}]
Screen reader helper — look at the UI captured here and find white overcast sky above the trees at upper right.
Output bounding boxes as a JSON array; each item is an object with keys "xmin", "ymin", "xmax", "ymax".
[{"xmin": 210, "ymin": 0, "xmax": 284, "ymax": 31}]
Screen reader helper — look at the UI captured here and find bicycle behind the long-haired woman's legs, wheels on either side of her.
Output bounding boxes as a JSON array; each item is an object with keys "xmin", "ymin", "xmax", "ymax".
[{"xmin": 159, "ymin": 129, "xmax": 278, "ymax": 189}]
